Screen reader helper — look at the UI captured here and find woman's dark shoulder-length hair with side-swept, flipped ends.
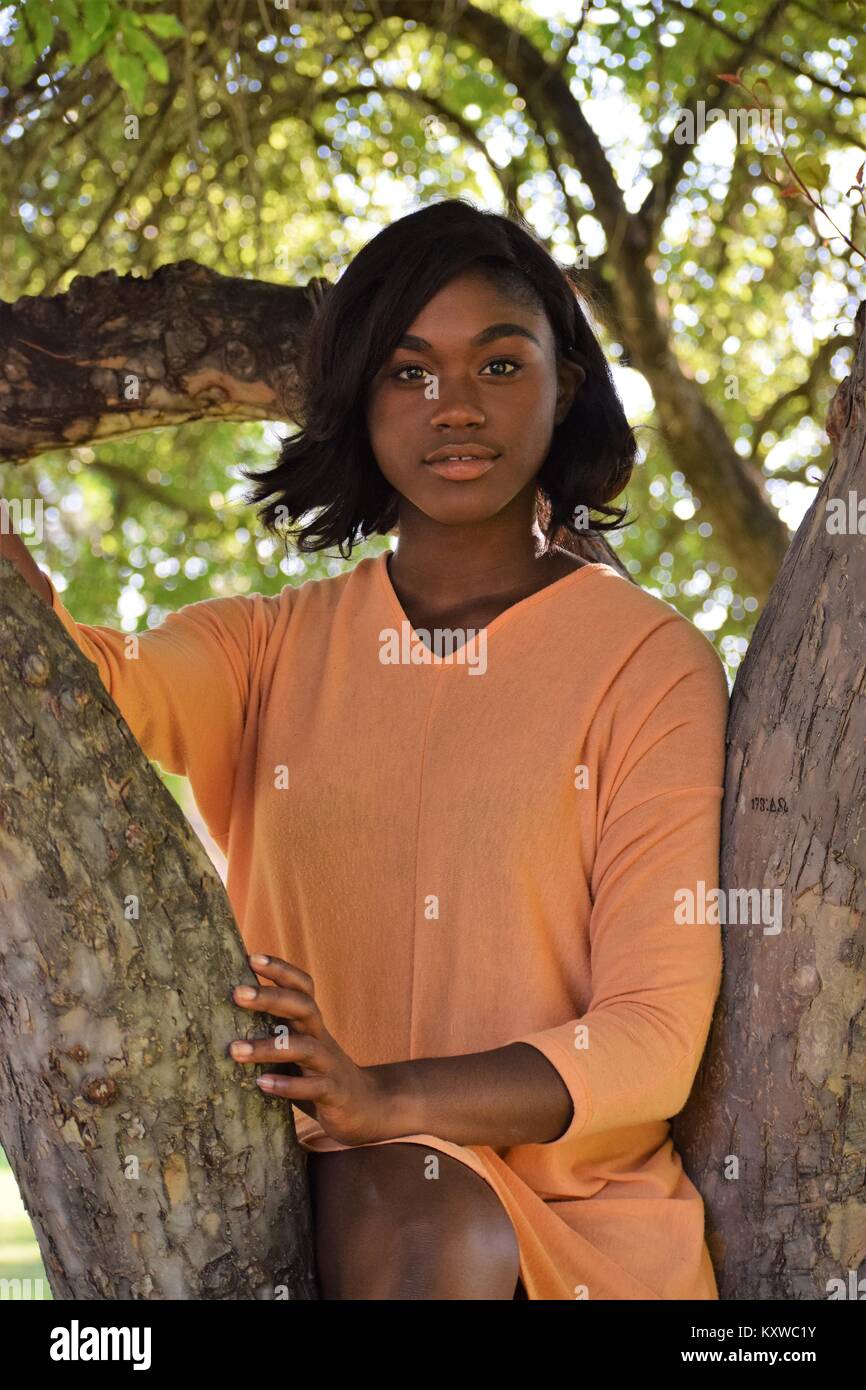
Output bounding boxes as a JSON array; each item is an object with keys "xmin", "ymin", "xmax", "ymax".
[{"xmin": 239, "ymin": 197, "xmax": 638, "ymax": 559}]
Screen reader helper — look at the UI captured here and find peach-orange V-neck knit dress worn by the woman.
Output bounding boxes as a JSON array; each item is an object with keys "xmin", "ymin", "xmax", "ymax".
[{"xmin": 44, "ymin": 550, "xmax": 728, "ymax": 1300}]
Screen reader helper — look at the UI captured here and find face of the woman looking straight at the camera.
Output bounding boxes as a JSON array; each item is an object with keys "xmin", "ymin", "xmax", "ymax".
[{"xmin": 367, "ymin": 272, "xmax": 585, "ymax": 525}]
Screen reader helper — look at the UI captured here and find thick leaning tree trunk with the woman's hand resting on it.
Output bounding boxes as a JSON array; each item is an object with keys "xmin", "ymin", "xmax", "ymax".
[{"xmin": 0, "ymin": 559, "xmax": 317, "ymax": 1300}]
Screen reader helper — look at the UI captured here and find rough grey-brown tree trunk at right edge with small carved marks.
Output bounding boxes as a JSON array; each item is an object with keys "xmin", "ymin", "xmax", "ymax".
[{"xmin": 674, "ymin": 298, "xmax": 866, "ymax": 1300}]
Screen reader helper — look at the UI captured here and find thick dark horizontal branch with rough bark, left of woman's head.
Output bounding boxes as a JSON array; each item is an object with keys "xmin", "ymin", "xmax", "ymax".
[{"xmin": 0, "ymin": 260, "xmax": 328, "ymax": 461}]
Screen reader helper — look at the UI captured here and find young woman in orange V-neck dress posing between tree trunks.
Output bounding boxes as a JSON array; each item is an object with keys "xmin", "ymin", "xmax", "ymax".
[{"xmin": 38, "ymin": 200, "xmax": 727, "ymax": 1300}]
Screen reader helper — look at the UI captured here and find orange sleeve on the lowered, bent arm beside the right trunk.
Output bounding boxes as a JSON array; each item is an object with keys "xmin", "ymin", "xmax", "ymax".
[{"xmin": 512, "ymin": 616, "xmax": 728, "ymax": 1148}]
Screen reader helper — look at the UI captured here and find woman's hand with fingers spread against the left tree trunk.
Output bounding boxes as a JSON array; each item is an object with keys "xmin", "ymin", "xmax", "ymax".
[{"xmin": 229, "ymin": 955, "xmax": 385, "ymax": 1144}]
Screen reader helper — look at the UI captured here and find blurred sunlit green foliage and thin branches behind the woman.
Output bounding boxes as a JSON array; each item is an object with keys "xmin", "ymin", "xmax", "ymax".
[{"xmin": 0, "ymin": 0, "xmax": 866, "ymax": 673}]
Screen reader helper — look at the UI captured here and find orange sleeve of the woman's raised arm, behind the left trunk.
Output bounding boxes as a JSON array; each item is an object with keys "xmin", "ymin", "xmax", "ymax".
[{"xmin": 43, "ymin": 571, "xmax": 279, "ymax": 841}]
